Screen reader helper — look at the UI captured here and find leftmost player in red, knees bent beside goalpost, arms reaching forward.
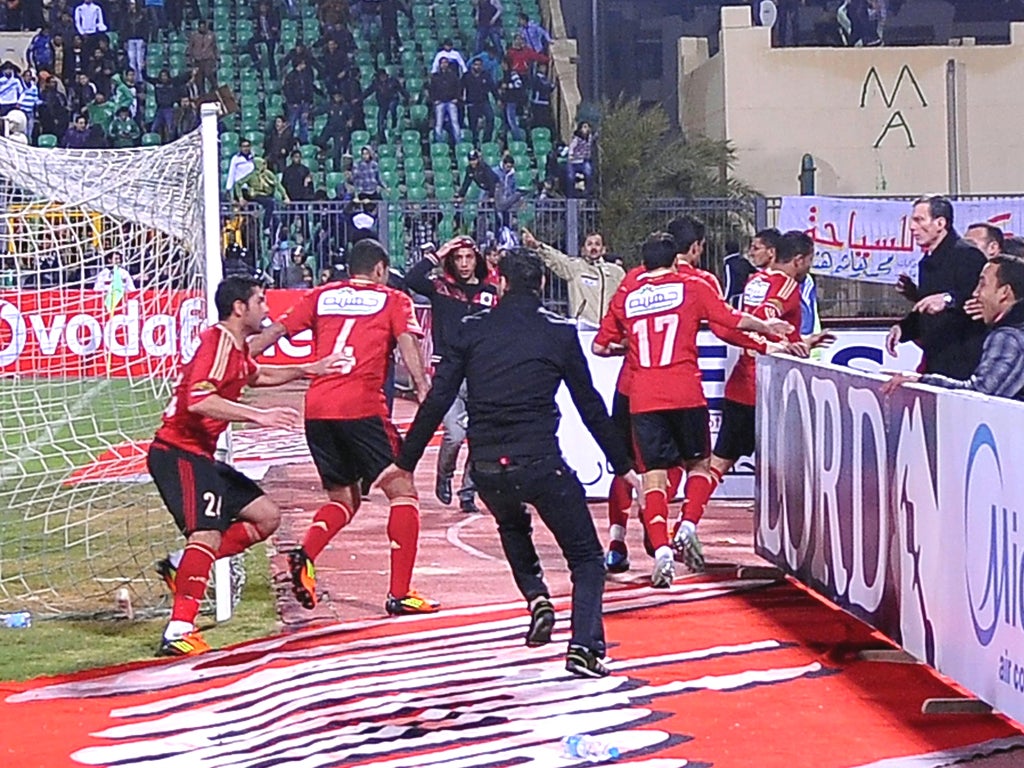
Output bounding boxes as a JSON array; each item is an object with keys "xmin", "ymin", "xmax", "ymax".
[{"xmin": 146, "ymin": 276, "xmax": 335, "ymax": 656}]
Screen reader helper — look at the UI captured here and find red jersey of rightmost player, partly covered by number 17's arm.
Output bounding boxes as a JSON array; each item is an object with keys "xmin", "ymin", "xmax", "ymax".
[{"xmin": 725, "ymin": 269, "xmax": 801, "ymax": 406}]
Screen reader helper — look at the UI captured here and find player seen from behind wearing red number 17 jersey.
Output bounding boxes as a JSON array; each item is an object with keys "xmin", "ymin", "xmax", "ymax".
[{"xmin": 593, "ymin": 232, "xmax": 793, "ymax": 587}]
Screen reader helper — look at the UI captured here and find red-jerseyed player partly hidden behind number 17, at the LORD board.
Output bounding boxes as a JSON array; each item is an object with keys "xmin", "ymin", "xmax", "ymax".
[{"xmin": 674, "ymin": 230, "xmax": 831, "ymax": 570}]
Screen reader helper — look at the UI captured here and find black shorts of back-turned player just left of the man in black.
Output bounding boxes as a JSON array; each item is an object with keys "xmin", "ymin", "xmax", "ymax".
[{"xmin": 306, "ymin": 416, "xmax": 401, "ymax": 489}]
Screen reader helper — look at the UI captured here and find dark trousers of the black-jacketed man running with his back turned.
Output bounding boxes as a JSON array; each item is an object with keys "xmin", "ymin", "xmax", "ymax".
[{"xmin": 471, "ymin": 456, "xmax": 605, "ymax": 656}]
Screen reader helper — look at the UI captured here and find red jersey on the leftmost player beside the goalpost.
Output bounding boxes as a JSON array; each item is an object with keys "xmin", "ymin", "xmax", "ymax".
[{"xmin": 157, "ymin": 323, "xmax": 259, "ymax": 458}]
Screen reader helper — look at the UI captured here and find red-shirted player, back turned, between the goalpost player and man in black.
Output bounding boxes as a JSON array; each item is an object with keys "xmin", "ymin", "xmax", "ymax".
[{"xmin": 250, "ymin": 240, "xmax": 438, "ymax": 615}]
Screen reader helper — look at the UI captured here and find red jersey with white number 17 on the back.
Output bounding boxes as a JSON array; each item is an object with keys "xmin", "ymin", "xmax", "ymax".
[{"xmin": 597, "ymin": 271, "xmax": 741, "ymax": 414}]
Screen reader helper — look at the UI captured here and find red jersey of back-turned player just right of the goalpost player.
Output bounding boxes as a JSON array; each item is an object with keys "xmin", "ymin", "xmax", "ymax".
[{"xmin": 280, "ymin": 278, "xmax": 423, "ymax": 419}]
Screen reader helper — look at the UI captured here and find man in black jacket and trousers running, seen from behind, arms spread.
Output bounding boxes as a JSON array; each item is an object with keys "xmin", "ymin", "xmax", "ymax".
[{"xmin": 381, "ymin": 249, "xmax": 639, "ymax": 677}]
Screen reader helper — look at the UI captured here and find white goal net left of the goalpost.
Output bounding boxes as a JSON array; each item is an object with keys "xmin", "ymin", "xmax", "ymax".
[{"xmin": 0, "ymin": 130, "xmax": 214, "ymax": 615}]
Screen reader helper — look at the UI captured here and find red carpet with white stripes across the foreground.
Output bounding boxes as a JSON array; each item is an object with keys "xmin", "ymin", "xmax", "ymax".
[{"xmin": 0, "ymin": 579, "xmax": 1024, "ymax": 768}]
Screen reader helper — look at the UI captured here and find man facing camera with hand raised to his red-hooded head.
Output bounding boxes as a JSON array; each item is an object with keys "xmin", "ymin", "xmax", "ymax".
[{"xmin": 406, "ymin": 238, "xmax": 497, "ymax": 513}]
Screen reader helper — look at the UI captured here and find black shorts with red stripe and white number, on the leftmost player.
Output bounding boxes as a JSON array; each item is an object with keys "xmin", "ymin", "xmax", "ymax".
[{"xmin": 146, "ymin": 440, "xmax": 263, "ymax": 536}]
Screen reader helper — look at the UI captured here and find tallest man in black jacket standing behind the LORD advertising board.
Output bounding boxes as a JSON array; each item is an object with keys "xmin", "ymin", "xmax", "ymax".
[{"xmin": 886, "ymin": 196, "xmax": 985, "ymax": 379}]
